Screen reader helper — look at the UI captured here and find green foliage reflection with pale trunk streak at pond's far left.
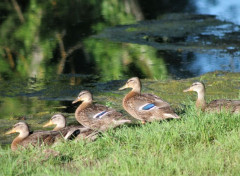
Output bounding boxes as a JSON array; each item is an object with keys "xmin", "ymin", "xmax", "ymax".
[{"xmin": 0, "ymin": 0, "xmax": 57, "ymax": 77}]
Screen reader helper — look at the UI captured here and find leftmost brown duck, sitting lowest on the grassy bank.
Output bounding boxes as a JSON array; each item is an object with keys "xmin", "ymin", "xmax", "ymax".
[{"xmin": 5, "ymin": 122, "xmax": 59, "ymax": 151}]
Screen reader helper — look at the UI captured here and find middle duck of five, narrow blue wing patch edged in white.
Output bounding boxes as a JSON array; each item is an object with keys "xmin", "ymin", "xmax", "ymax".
[{"xmin": 72, "ymin": 90, "xmax": 131, "ymax": 131}]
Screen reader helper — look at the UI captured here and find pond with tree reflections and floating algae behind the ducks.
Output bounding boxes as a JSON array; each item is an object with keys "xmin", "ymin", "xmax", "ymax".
[{"xmin": 0, "ymin": 0, "xmax": 240, "ymax": 144}]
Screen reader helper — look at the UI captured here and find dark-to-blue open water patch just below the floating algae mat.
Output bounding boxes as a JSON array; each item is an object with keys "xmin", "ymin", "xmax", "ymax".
[{"xmin": 159, "ymin": 51, "xmax": 240, "ymax": 79}]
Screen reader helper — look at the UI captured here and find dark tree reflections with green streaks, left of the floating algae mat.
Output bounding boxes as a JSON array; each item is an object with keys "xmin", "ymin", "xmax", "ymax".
[{"xmin": 0, "ymin": 0, "xmax": 194, "ymax": 80}]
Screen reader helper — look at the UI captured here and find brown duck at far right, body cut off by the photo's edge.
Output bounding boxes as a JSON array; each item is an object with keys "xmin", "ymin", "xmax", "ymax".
[{"xmin": 183, "ymin": 82, "xmax": 240, "ymax": 113}]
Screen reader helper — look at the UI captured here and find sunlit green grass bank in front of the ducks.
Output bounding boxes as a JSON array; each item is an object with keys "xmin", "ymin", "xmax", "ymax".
[{"xmin": 0, "ymin": 105, "xmax": 240, "ymax": 176}]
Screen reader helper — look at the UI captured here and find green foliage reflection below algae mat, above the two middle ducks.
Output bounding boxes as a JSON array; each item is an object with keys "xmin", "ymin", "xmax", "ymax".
[{"xmin": 85, "ymin": 39, "xmax": 167, "ymax": 80}]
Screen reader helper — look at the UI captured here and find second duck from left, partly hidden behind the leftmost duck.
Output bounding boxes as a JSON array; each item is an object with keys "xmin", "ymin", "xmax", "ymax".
[{"xmin": 43, "ymin": 114, "xmax": 97, "ymax": 141}]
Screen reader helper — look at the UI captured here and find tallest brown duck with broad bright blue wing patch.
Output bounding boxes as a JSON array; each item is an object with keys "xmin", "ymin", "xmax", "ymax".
[{"xmin": 119, "ymin": 77, "xmax": 180, "ymax": 123}]
